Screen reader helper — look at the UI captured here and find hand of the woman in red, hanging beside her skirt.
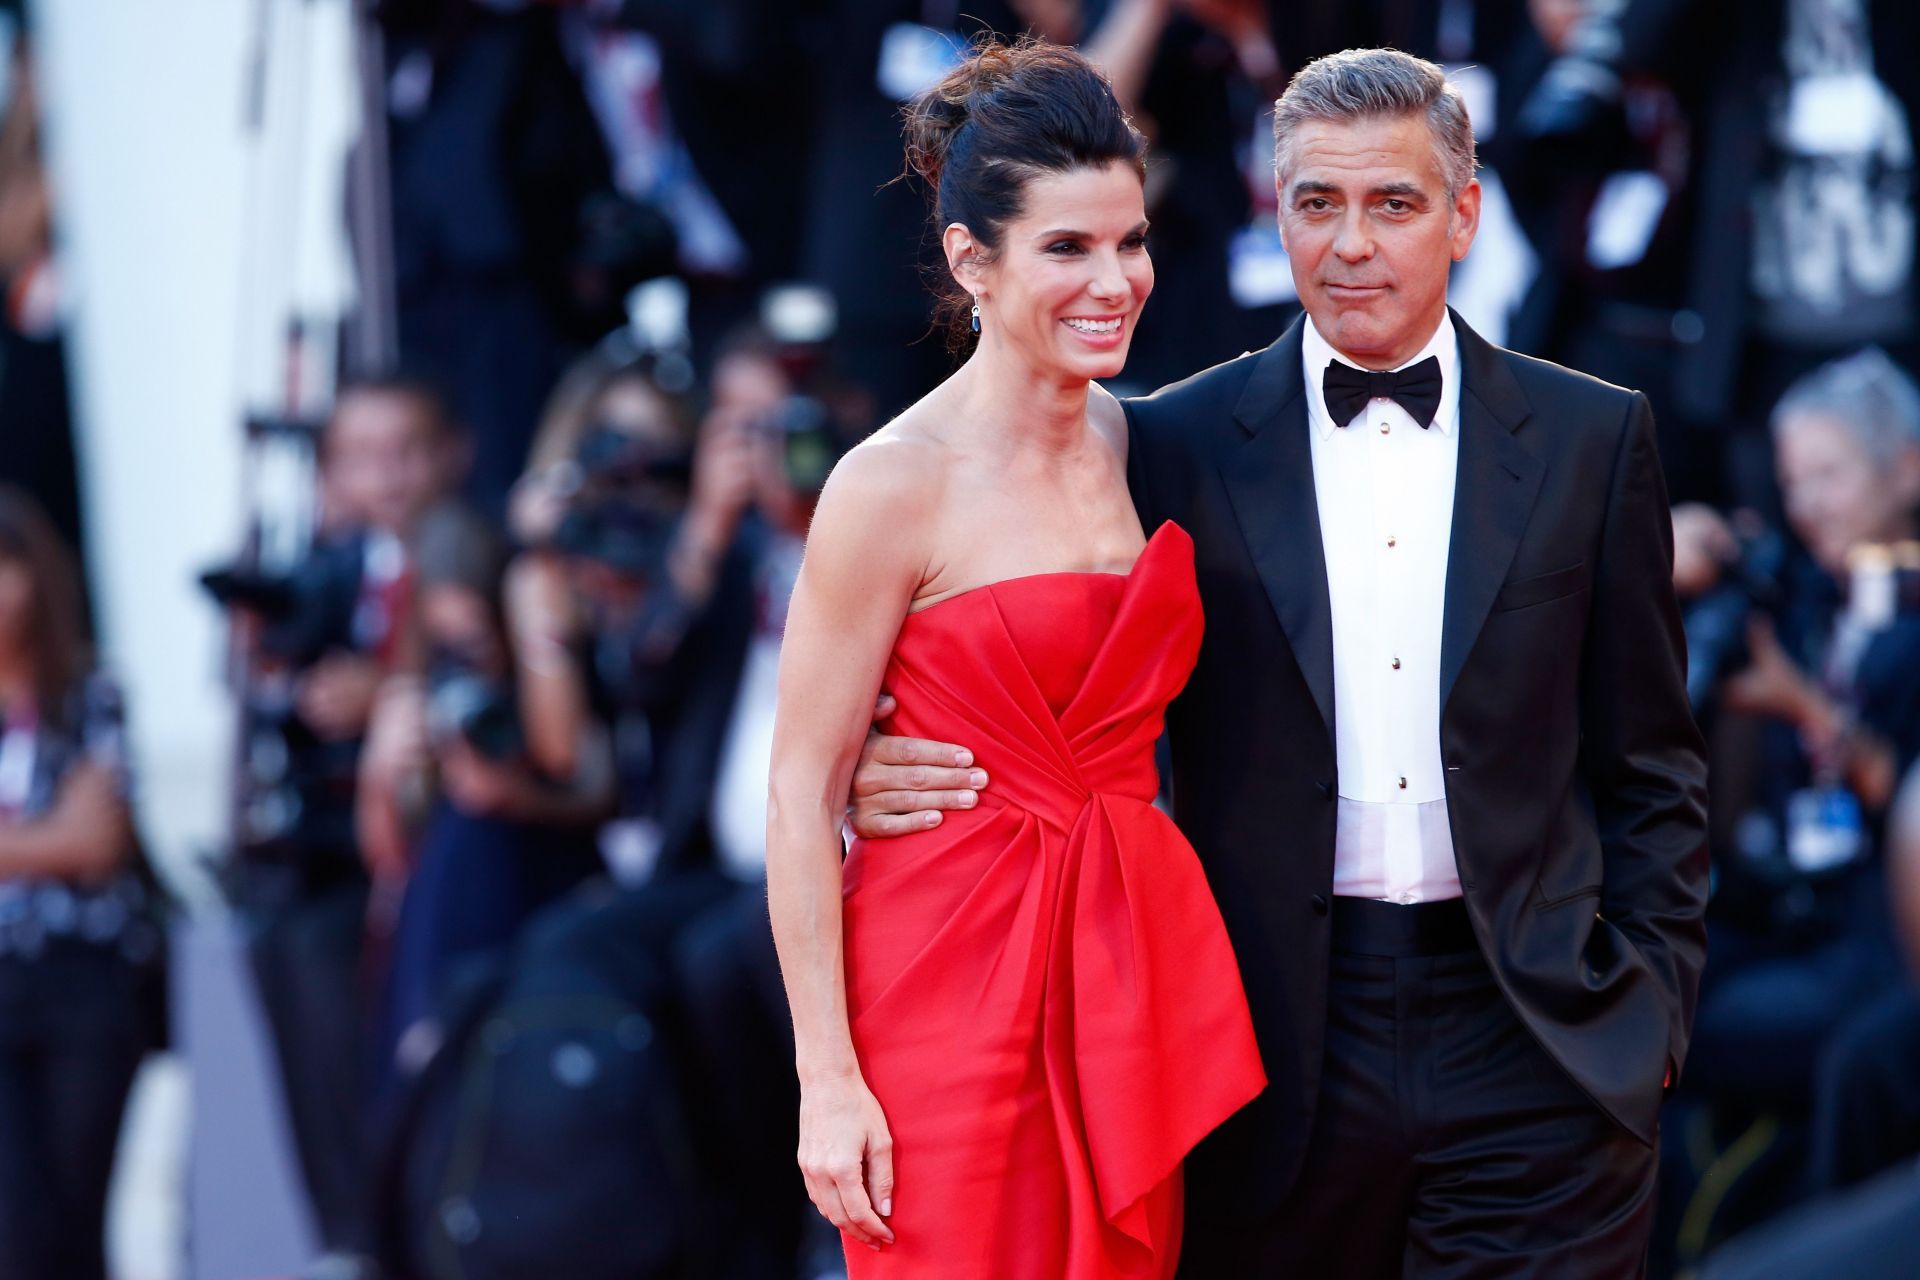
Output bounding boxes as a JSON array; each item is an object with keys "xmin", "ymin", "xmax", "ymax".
[{"xmin": 801, "ymin": 1073, "xmax": 893, "ymax": 1249}]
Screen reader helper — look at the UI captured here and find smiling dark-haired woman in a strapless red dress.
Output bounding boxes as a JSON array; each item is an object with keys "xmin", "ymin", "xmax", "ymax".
[{"xmin": 768, "ymin": 44, "xmax": 1265, "ymax": 1280}]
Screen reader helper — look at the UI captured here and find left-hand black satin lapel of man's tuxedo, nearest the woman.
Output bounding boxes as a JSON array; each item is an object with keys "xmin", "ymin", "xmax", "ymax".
[{"xmin": 1221, "ymin": 385, "xmax": 1332, "ymax": 733}]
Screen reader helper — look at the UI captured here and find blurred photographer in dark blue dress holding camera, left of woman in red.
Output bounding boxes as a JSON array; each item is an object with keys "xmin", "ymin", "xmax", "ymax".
[{"xmin": 357, "ymin": 507, "xmax": 612, "ymax": 1090}]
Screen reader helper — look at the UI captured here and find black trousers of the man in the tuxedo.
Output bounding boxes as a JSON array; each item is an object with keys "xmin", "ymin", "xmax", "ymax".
[{"xmin": 1181, "ymin": 898, "xmax": 1655, "ymax": 1280}]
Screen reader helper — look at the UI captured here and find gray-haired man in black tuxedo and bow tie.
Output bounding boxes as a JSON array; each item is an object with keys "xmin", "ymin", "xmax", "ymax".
[{"xmin": 854, "ymin": 50, "xmax": 1707, "ymax": 1280}]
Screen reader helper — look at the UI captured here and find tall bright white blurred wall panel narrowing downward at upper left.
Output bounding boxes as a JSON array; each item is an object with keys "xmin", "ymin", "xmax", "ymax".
[{"xmin": 31, "ymin": 0, "xmax": 253, "ymax": 901}]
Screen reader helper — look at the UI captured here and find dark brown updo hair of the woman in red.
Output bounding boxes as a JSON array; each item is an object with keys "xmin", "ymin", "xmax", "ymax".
[{"xmin": 906, "ymin": 40, "xmax": 1146, "ymax": 342}]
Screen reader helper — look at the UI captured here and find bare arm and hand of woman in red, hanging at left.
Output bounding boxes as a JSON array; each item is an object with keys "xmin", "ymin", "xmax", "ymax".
[{"xmin": 766, "ymin": 439, "xmax": 937, "ymax": 1245}]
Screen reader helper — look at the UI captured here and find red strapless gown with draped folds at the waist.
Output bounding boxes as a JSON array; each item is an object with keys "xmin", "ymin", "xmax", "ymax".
[{"xmin": 845, "ymin": 524, "xmax": 1265, "ymax": 1280}]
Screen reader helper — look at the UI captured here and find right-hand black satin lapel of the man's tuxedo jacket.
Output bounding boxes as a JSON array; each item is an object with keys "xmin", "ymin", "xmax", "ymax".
[{"xmin": 1440, "ymin": 379, "xmax": 1546, "ymax": 710}]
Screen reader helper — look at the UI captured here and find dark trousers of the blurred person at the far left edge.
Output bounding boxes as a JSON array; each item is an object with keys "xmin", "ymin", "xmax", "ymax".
[{"xmin": 0, "ymin": 944, "xmax": 146, "ymax": 1280}]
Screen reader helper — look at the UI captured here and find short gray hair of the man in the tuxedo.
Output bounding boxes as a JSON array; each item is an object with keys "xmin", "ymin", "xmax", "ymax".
[{"xmin": 1273, "ymin": 48, "xmax": 1478, "ymax": 203}]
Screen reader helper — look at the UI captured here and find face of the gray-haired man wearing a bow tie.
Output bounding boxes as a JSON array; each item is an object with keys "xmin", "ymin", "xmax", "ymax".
[{"xmin": 1279, "ymin": 115, "xmax": 1480, "ymax": 368}]
